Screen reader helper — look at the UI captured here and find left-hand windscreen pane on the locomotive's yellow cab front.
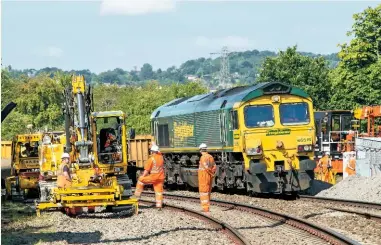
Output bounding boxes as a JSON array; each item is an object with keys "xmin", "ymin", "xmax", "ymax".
[{"xmin": 245, "ymin": 105, "xmax": 275, "ymax": 128}]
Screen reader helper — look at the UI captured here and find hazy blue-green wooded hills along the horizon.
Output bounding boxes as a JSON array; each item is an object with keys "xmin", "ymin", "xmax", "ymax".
[{"xmin": 8, "ymin": 50, "xmax": 338, "ymax": 87}]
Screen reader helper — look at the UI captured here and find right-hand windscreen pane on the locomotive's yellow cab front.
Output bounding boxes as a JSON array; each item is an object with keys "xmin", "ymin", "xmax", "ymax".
[{"xmin": 279, "ymin": 102, "xmax": 310, "ymax": 125}]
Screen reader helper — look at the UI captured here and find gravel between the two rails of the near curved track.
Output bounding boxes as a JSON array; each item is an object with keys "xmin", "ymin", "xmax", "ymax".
[{"xmin": 144, "ymin": 197, "xmax": 329, "ymax": 245}]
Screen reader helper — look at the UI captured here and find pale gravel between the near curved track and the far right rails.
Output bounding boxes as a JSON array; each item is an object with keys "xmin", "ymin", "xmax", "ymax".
[{"xmin": 154, "ymin": 191, "xmax": 381, "ymax": 245}]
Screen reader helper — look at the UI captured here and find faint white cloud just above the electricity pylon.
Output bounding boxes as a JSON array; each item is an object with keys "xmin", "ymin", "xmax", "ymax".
[{"xmin": 195, "ymin": 36, "xmax": 253, "ymax": 49}]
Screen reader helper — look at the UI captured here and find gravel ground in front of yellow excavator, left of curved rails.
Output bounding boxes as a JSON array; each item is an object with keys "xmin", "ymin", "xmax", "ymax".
[{"xmin": 1, "ymin": 206, "xmax": 232, "ymax": 245}]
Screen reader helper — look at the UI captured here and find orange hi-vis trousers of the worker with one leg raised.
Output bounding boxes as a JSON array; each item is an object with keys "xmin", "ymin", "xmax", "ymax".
[{"xmin": 135, "ymin": 174, "xmax": 164, "ymax": 208}]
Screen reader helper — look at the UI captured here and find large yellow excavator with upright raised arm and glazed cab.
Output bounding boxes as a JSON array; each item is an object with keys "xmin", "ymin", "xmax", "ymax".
[{"xmin": 36, "ymin": 76, "xmax": 138, "ymax": 215}]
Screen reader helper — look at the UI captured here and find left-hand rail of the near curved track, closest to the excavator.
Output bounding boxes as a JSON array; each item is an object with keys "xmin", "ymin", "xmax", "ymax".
[{"xmin": 139, "ymin": 200, "xmax": 250, "ymax": 245}]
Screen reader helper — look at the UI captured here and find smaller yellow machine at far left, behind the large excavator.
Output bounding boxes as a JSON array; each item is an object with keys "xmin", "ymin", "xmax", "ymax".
[{"xmin": 5, "ymin": 133, "xmax": 42, "ymax": 201}]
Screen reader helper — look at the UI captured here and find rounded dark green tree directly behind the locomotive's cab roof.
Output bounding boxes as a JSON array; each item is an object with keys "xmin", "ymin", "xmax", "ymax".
[{"xmin": 258, "ymin": 46, "xmax": 331, "ymax": 109}]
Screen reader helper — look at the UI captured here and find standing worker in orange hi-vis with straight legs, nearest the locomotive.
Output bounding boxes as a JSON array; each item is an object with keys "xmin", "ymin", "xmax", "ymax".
[{"xmin": 198, "ymin": 143, "xmax": 216, "ymax": 213}]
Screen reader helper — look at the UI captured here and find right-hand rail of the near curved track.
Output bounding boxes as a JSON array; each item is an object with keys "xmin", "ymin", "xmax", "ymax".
[{"xmin": 143, "ymin": 191, "xmax": 360, "ymax": 245}]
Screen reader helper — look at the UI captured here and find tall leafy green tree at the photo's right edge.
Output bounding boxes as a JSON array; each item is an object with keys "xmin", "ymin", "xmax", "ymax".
[{"xmin": 330, "ymin": 5, "xmax": 381, "ymax": 109}]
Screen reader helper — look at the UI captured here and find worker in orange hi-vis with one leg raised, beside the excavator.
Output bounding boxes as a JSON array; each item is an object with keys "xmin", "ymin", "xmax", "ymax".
[{"xmin": 133, "ymin": 145, "xmax": 165, "ymax": 210}]
